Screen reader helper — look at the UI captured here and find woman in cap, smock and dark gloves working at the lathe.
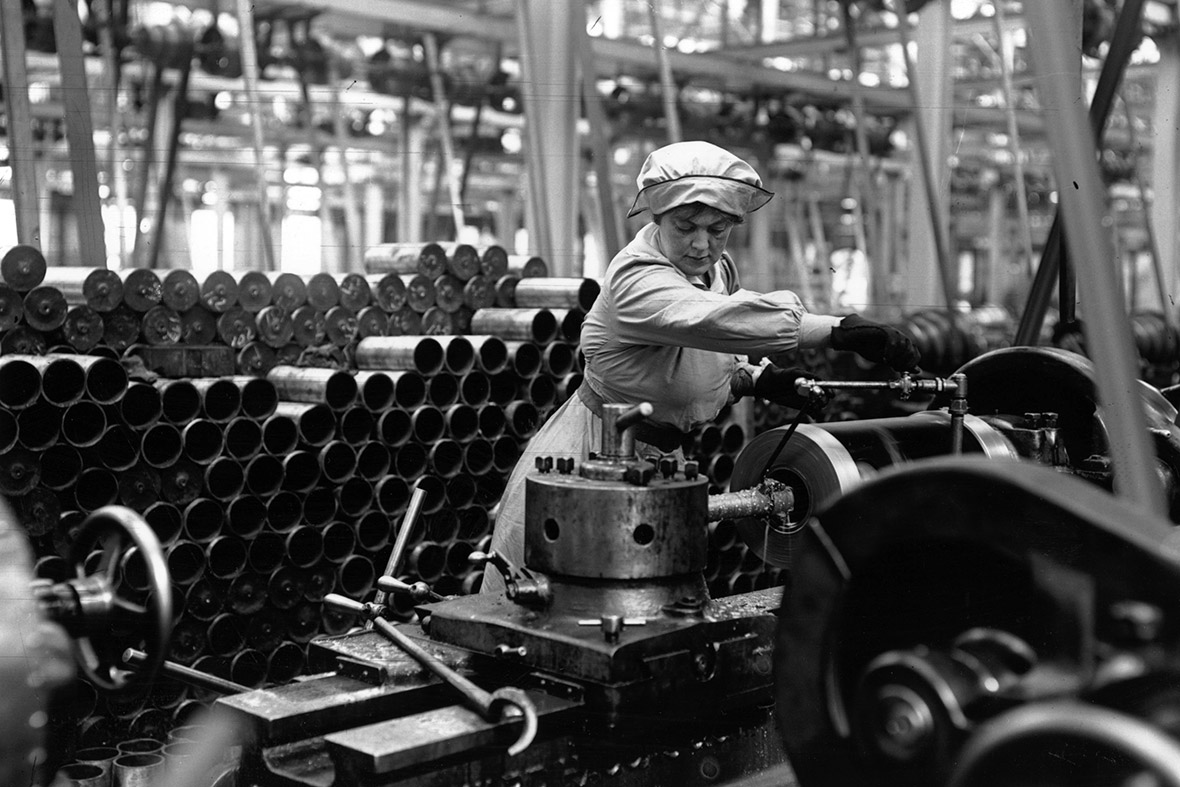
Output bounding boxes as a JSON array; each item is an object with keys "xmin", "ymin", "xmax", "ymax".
[{"xmin": 483, "ymin": 142, "xmax": 919, "ymax": 592}]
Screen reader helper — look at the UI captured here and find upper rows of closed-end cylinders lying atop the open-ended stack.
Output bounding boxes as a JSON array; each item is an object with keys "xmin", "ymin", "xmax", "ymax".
[{"xmin": 0, "ymin": 243, "xmax": 585, "ymax": 375}]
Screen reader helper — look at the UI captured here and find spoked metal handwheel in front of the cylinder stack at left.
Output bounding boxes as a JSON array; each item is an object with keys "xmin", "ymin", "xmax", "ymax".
[{"xmin": 63, "ymin": 505, "xmax": 172, "ymax": 694}]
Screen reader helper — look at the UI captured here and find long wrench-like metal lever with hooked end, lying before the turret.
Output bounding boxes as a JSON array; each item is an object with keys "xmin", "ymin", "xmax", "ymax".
[{"xmin": 323, "ymin": 593, "xmax": 537, "ymax": 755}]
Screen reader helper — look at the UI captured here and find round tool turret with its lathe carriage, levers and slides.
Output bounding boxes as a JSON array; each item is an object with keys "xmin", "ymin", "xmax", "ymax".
[{"xmin": 217, "ymin": 405, "xmax": 793, "ymax": 785}]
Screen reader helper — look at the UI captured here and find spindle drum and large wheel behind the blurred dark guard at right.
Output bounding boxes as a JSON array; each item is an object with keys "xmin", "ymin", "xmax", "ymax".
[{"xmin": 729, "ymin": 347, "xmax": 1180, "ymax": 568}]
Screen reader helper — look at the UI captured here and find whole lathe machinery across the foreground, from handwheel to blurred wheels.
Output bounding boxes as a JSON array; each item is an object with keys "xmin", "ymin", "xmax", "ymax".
[{"xmin": 5, "ymin": 348, "xmax": 1180, "ymax": 787}]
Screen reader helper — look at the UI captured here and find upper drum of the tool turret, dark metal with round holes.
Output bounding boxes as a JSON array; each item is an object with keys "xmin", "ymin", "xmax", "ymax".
[{"xmin": 525, "ymin": 473, "xmax": 708, "ymax": 579}]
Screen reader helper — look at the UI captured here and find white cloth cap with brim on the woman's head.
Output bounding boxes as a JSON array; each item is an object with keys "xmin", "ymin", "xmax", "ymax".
[{"xmin": 627, "ymin": 140, "xmax": 774, "ymax": 217}]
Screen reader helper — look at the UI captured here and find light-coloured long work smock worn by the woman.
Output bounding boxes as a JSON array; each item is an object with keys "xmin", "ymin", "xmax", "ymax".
[{"xmin": 481, "ymin": 224, "xmax": 839, "ymax": 592}]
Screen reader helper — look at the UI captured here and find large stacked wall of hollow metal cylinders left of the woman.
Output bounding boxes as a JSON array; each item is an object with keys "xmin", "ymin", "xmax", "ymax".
[{"xmin": 0, "ymin": 244, "xmax": 618, "ymax": 745}]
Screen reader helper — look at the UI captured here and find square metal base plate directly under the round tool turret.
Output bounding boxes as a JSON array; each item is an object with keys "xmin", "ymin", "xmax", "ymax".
[{"xmin": 424, "ymin": 589, "xmax": 781, "ymax": 704}]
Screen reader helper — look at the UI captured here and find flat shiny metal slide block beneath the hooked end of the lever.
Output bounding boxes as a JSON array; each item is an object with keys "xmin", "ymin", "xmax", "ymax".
[{"xmin": 325, "ymin": 691, "xmax": 581, "ymax": 774}]
